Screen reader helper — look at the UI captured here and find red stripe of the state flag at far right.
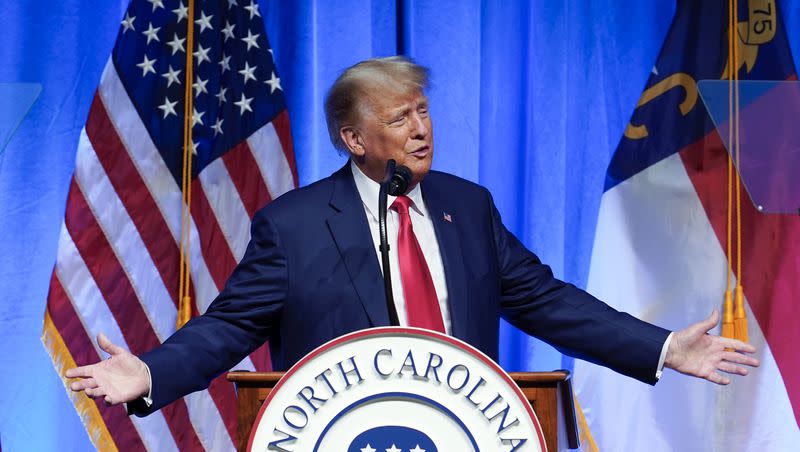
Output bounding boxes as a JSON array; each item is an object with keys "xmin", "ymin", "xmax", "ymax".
[{"xmin": 680, "ymin": 131, "xmax": 800, "ymax": 419}]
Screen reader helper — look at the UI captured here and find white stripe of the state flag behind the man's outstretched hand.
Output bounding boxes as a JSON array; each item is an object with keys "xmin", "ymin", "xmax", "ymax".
[{"xmin": 574, "ymin": 154, "xmax": 800, "ymax": 452}]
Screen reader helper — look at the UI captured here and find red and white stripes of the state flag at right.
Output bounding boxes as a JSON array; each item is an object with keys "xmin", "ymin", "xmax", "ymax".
[{"xmin": 574, "ymin": 133, "xmax": 800, "ymax": 452}]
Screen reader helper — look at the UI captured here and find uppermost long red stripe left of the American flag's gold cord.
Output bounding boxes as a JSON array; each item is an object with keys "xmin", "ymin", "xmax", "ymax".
[{"xmin": 86, "ymin": 93, "xmax": 180, "ymax": 307}]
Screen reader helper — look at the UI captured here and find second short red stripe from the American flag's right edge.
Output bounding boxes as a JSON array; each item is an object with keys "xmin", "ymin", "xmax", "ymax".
[{"xmin": 222, "ymin": 141, "xmax": 272, "ymax": 219}]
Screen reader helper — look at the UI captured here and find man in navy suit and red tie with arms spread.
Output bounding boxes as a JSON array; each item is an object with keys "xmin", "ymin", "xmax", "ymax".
[{"xmin": 67, "ymin": 57, "xmax": 758, "ymax": 415}]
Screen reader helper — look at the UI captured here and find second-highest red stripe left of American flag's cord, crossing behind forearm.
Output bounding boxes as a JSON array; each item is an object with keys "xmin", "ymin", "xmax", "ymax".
[{"xmin": 65, "ymin": 178, "xmax": 203, "ymax": 450}]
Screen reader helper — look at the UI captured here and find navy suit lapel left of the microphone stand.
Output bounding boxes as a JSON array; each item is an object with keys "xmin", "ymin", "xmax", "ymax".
[{"xmin": 327, "ymin": 162, "xmax": 389, "ymax": 326}]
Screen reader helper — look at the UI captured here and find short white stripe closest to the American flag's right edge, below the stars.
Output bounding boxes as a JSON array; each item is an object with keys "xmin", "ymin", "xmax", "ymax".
[{"xmin": 247, "ymin": 122, "xmax": 294, "ymax": 199}]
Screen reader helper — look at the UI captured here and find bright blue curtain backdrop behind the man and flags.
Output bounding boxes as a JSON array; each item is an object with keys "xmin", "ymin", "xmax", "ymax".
[{"xmin": 0, "ymin": 0, "xmax": 800, "ymax": 451}]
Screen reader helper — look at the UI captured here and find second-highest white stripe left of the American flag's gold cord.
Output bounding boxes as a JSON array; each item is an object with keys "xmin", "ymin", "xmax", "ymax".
[{"xmin": 75, "ymin": 129, "xmax": 178, "ymax": 342}]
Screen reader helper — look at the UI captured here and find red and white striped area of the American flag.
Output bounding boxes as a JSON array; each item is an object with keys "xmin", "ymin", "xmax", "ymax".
[{"xmin": 43, "ymin": 60, "xmax": 297, "ymax": 450}]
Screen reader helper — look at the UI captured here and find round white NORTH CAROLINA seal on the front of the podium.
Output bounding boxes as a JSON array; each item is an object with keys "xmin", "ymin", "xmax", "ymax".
[{"xmin": 247, "ymin": 327, "xmax": 546, "ymax": 452}]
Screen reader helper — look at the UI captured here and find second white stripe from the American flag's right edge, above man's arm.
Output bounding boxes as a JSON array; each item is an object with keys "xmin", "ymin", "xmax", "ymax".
[{"xmin": 198, "ymin": 158, "xmax": 250, "ymax": 262}]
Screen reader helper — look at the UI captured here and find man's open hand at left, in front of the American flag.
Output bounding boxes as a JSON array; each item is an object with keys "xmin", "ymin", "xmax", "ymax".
[{"xmin": 66, "ymin": 333, "xmax": 150, "ymax": 405}]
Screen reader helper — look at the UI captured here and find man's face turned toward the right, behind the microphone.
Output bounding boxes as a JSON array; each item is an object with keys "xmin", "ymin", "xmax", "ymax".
[{"xmin": 353, "ymin": 87, "xmax": 433, "ymax": 186}]
